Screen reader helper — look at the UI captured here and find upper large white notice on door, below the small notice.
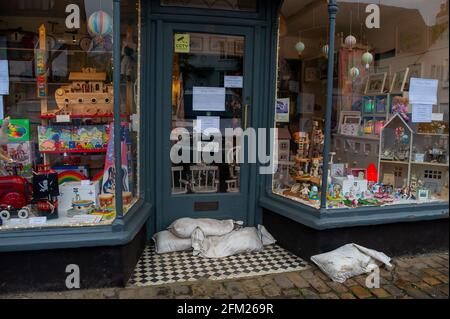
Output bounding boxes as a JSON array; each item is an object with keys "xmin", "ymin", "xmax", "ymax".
[{"xmin": 192, "ymin": 86, "xmax": 225, "ymax": 112}]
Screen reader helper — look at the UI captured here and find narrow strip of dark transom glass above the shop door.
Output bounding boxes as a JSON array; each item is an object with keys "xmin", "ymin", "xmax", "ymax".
[{"xmin": 161, "ymin": 0, "xmax": 257, "ymax": 11}]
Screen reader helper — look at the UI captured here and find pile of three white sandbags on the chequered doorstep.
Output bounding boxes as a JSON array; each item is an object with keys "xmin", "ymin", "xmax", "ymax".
[{"xmin": 153, "ymin": 218, "xmax": 276, "ymax": 258}]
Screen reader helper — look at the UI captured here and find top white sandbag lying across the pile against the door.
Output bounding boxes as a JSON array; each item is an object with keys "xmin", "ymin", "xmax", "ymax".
[{"xmin": 169, "ymin": 218, "xmax": 241, "ymax": 238}]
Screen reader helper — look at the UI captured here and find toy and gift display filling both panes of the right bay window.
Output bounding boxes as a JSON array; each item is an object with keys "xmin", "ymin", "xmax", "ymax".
[{"xmin": 273, "ymin": 0, "xmax": 449, "ymax": 209}]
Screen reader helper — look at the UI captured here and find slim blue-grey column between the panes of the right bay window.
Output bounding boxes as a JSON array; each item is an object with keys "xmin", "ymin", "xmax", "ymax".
[{"xmin": 320, "ymin": 0, "xmax": 338, "ymax": 208}]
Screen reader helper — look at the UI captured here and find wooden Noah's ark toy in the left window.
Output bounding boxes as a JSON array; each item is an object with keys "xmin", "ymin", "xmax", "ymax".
[{"xmin": 43, "ymin": 68, "xmax": 114, "ymax": 115}]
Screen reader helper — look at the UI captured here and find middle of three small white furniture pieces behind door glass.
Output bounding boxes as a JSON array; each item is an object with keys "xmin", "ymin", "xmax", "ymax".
[{"xmin": 190, "ymin": 165, "xmax": 219, "ymax": 194}]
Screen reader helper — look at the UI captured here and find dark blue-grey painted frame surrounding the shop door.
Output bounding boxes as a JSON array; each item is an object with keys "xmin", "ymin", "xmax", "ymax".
[{"xmin": 141, "ymin": 0, "xmax": 280, "ymax": 237}]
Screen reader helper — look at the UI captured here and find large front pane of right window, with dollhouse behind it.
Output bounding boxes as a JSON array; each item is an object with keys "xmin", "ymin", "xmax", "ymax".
[{"xmin": 328, "ymin": 0, "xmax": 449, "ymax": 208}]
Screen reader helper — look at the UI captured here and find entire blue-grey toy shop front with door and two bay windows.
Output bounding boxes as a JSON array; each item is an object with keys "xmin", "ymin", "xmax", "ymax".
[{"xmin": 0, "ymin": 0, "xmax": 449, "ymax": 292}]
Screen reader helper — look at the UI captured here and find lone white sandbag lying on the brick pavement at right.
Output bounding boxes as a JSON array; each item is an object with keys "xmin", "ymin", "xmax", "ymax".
[{"xmin": 311, "ymin": 244, "xmax": 392, "ymax": 283}]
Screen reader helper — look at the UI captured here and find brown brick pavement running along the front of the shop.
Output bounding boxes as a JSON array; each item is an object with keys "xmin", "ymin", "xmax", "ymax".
[{"xmin": 0, "ymin": 252, "xmax": 449, "ymax": 299}]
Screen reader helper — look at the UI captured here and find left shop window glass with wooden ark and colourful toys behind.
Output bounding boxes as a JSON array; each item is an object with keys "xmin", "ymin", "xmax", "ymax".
[{"xmin": 0, "ymin": 0, "xmax": 139, "ymax": 230}]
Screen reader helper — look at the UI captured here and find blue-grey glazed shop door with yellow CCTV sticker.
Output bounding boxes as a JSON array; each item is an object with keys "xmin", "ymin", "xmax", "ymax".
[{"xmin": 156, "ymin": 24, "xmax": 255, "ymax": 230}]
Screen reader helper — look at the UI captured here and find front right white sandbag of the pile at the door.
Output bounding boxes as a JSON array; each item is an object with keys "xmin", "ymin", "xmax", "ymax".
[{"xmin": 192, "ymin": 227, "xmax": 264, "ymax": 258}]
